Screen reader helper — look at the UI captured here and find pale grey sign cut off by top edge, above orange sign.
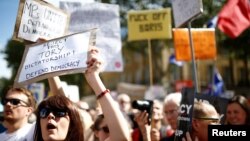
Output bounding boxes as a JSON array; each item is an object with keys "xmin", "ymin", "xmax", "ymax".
[{"xmin": 172, "ymin": 0, "xmax": 203, "ymax": 27}]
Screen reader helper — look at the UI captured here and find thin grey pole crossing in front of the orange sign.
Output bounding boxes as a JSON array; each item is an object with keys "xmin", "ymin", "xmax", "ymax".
[{"xmin": 188, "ymin": 21, "xmax": 200, "ymax": 93}]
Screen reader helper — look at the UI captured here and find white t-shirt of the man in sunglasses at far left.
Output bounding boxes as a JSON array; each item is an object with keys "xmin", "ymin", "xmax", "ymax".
[{"xmin": 0, "ymin": 122, "xmax": 36, "ymax": 141}]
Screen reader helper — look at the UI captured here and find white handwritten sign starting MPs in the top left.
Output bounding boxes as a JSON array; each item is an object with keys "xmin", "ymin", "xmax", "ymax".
[{"xmin": 13, "ymin": 0, "xmax": 69, "ymax": 42}]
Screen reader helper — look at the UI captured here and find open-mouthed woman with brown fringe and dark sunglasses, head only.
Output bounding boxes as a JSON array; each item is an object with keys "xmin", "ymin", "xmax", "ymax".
[{"xmin": 34, "ymin": 94, "xmax": 84, "ymax": 141}]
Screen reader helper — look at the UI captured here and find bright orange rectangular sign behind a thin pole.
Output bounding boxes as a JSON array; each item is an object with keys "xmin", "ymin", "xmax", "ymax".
[{"xmin": 173, "ymin": 28, "xmax": 217, "ymax": 61}]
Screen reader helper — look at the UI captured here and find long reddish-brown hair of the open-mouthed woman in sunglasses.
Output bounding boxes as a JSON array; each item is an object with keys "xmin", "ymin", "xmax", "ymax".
[{"xmin": 34, "ymin": 94, "xmax": 84, "ymax": 141}]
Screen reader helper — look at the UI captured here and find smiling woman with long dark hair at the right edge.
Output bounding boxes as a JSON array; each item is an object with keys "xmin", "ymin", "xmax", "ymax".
[{"xmin": 225, "ymin": 95, "xmax": 250, "ymax": 125}]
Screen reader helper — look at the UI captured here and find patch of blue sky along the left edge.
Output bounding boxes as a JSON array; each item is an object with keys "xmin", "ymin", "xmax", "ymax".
[{"xmin": 0, "ymin": 0, "xmax": 19, "ymax": 78}]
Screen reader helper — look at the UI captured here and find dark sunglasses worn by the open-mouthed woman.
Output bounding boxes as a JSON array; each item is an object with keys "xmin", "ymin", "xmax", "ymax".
[{"xmin": 39, "ymin": 108, "xmax": 67, "ymax": 118}]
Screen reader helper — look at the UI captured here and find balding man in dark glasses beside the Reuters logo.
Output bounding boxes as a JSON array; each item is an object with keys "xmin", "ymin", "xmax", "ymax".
[{"xmin": 182, "ymin": 101, "xmax": 220, "ymax": 141}]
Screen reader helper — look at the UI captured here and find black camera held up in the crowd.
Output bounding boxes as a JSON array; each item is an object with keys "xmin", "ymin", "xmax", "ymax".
[{"xmin": 132, "ymin": 100, "xmax": 154, "ymax": 124}]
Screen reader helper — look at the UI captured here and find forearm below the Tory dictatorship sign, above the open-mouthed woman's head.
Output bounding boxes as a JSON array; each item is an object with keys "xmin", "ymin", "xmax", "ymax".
[{"xmin": 48, "ymin": 76, "xmax": 65, "ymax": 95}]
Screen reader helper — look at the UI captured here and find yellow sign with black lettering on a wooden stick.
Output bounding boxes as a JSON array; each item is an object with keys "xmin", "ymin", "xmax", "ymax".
[{"xmin": 128, "ymin": 8, "xmax": 172, "ymax": 41}]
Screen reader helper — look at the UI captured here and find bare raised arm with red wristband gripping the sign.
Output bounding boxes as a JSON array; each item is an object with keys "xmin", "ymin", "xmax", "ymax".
[{"xmin": 85, "ymin": 48, "xmax": 130, "ymax": 141}]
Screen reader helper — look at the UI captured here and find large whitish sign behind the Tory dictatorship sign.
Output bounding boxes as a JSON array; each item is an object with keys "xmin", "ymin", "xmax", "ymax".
[{"xmin": 60, "ymin": 2, "xmax": 123, "ymax": 72}]
